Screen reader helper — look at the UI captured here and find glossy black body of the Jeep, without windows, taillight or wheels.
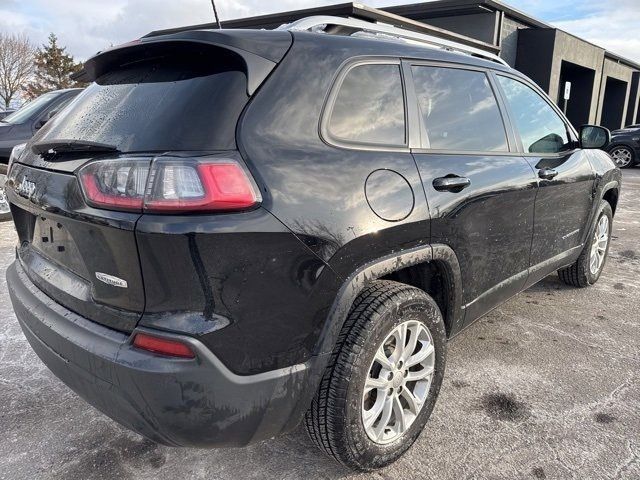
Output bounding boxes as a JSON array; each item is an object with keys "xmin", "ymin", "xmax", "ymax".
[{"xmin": 7, "ymin": 26, "xmax": 620, "ymax": 446}]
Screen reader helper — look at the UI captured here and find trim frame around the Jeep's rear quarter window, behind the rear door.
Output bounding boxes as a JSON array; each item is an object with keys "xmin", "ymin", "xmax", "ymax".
[{"xmin": 319, "ymin": 56, "xmax": 410, "ymax": 152}]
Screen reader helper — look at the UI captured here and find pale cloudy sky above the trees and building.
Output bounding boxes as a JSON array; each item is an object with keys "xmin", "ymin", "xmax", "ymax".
[{"xmin": 0, "ymin": 0, "xmax": 640, "ymax": 62}]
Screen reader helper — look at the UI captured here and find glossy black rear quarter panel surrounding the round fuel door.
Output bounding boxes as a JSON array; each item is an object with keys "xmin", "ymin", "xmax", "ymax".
[{"xmin": 238, "ymin": 34, "xmax": 430, "ymax": 278}]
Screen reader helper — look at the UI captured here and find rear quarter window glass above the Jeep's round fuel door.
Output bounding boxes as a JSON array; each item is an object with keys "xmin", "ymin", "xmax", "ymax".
[{"xmin": 328, "ymin": 65, "xmax": 406, "ymax": 145}]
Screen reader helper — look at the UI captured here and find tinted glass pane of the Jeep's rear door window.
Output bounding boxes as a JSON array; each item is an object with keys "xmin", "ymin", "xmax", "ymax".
[{"xmin": 411, "ymin": 66, "xmax": 508, "ymax": 152}]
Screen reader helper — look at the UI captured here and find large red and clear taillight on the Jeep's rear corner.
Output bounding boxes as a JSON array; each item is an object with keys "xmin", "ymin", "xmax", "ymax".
[{"xmin": 78, "ymin": 157, "xmax": 259, "ymax": 213}]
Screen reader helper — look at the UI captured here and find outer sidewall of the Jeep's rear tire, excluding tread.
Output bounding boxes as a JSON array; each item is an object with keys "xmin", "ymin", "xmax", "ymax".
[{"xmin": 344, "ymin": 290, "xmax": 446, "ymax": 470}]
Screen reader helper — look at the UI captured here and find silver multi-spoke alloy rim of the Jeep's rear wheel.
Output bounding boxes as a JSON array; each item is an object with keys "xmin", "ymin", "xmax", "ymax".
[{"xmin": 362, "ymin": 320, "xmax": 436, "ymax": 444}]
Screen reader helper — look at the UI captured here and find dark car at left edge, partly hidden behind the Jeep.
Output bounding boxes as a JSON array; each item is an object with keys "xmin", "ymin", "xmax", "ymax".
[{"xmin": 0, "ymin": 88, "xmax": 82, "ymax": 222}]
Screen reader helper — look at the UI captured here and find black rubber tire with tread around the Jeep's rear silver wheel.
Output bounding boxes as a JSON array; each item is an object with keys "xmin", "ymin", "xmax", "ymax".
[{"xmin": 305, "ymin": 280, "xmax": 446, "ymax": 471}]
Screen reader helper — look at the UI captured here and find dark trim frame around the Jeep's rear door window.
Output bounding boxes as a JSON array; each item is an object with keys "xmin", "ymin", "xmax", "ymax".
[{"xmin": 402, "ymin": 59, "xmax": 519, "ymax": 156}]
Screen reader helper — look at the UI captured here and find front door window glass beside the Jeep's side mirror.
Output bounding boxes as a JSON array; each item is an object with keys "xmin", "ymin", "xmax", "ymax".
[{"xmin": 498, "ymin": 76, "xmax": 570, "ymax": 153}]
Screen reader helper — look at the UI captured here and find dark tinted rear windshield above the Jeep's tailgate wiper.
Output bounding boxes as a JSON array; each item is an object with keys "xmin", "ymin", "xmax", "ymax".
[{"xmin": 38, "ymin": 44, "xmax": 248, "ymax": 152}]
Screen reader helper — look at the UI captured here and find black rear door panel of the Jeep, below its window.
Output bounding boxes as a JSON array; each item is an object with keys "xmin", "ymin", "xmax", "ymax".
[{"xmin": 414, "ymin": 153, "xmax": 537, "ymax": 321}]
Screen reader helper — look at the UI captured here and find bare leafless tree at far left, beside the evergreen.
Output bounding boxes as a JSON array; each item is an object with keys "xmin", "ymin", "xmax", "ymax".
[{"xmin": 0, "ymin": 33, "xmax": 35, "ymax": 108}]
